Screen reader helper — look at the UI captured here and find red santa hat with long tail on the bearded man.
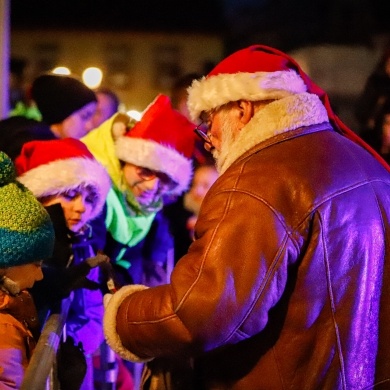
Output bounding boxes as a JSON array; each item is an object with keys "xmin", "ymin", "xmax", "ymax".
[{"xmin": 187, "ymin": 45, "xmax": 390, "ymax": 171}]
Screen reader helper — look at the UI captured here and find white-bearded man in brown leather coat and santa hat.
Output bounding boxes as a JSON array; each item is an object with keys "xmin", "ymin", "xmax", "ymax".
[{"xmin": 105, "ymin": 45, "xmax": 390, "ymax": 390}]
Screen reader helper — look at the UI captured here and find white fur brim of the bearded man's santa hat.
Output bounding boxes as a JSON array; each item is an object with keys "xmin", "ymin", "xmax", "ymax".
[{"xmin": 187, "ymin": 70, "xmax": 307, "ymax": 120}]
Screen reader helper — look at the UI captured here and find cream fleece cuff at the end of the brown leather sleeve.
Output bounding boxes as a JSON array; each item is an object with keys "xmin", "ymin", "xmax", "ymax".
[{"xmin": 103, "ymin": 284, "xmax": 153, "ymax": 363}]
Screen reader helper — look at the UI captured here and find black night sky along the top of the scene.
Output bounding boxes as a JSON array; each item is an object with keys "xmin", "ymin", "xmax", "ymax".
[{"xmin": 10, "ymin": 0, "xmax": 390, "ymax": 50}]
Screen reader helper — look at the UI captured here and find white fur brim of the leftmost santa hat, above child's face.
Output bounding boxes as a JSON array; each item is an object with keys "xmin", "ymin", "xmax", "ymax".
[{"xmin": 18, "ymin": 157, "xmax": 111, "ymax": 219}]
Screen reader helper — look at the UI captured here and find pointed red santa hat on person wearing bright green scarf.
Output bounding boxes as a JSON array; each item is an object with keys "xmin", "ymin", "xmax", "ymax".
[{"xmin": 115, "ymin": 94, "xmax": 195, "ymax": 194}]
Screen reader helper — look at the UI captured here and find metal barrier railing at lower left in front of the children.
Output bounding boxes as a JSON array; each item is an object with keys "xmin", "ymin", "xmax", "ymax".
[{"xmin": 20, "ymin": 299, "xmax": 71, "ymax": 390}]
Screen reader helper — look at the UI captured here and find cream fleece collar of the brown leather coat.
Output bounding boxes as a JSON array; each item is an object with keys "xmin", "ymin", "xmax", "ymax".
[{"xmin": 218, "ymin": 93, "xmax": 329, "ymax": 174}]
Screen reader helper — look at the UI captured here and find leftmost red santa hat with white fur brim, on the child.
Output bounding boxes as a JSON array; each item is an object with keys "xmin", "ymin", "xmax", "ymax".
[{"xmin": 15, "ymin": 138, "xmax": 111, "ymax": 219}]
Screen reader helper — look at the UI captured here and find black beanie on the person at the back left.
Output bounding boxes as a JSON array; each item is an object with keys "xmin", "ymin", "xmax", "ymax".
[{"xmin": 31, "ymin": 74, "xmax": 97, "ymax": 125}]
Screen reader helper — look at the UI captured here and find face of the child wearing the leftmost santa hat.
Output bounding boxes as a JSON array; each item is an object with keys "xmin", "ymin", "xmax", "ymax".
[{"xmin": 42, "ymin": 188, "xmax": 96, "ymax": 232}]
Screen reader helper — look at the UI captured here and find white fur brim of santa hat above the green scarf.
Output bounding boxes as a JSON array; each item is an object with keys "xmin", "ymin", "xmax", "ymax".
[{"xmin": 115, "ymin": 136, "xmax": 192, "ymax": 195}]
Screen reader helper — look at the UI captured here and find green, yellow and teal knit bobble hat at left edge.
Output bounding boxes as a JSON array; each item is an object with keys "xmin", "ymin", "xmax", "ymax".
[{"xmin": 0, "ymin": 152, "xmax": 54, "ymax": 268}]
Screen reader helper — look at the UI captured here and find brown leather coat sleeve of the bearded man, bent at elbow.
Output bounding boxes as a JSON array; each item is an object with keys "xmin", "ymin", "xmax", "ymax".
[{"xmin": 102, "ymin": 187, "xmax": 296, "ymax": 359}]
